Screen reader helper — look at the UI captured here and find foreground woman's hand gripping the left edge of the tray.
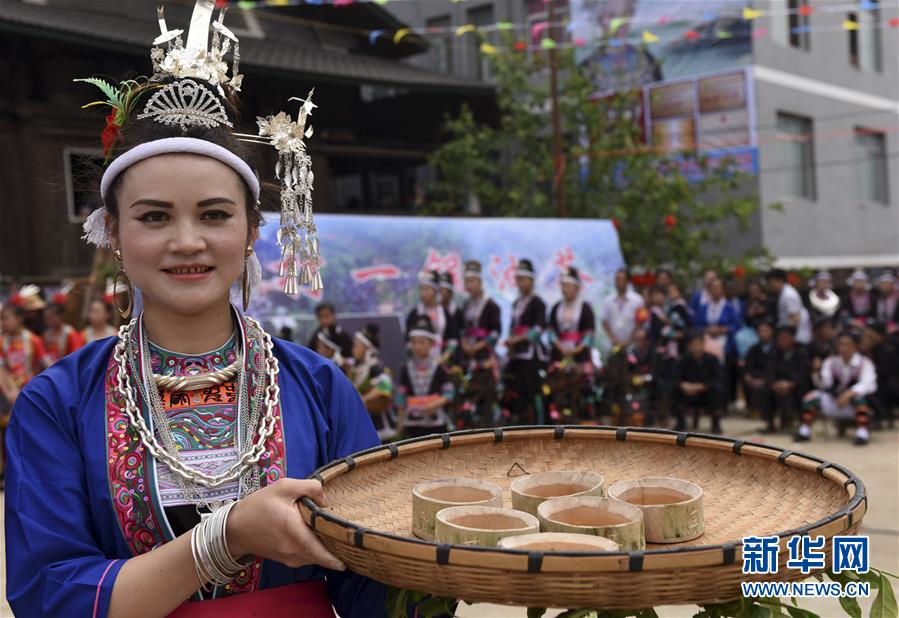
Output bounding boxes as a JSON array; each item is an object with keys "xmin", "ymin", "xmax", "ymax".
[{"xmin": 226, "ymin": 478, "xmax": 346, "ymax": 571}]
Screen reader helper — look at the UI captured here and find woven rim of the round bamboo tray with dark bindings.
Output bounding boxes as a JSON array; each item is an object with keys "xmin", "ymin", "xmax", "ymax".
[{"xmin": 301, "ymin": 425, "xmax": 867, "ymax": 573}]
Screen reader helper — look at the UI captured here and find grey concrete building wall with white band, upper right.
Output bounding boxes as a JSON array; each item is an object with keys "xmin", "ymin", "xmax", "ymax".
[{"xmin": 753, "ymin": 2, "xmax": 899, "ymax": 267}]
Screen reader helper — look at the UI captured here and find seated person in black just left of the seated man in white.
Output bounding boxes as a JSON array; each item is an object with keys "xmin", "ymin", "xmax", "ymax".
[{"xmin": 768, "ymin": 326, "xmax": 811, "ymax": 430}]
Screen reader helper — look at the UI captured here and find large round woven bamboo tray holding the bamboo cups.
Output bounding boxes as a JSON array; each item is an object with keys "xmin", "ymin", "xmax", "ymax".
[{"xmin": 300, "ymin": 426, "xmax": 867, "ymax": 609}]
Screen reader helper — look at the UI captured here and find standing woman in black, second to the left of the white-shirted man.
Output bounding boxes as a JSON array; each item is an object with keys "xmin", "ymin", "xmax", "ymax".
[{"xmin": 505, "ymin": 260, "xmax": 547, "ymax": 424}]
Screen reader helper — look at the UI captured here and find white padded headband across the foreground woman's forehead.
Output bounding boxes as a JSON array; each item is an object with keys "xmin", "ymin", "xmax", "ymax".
[{"xmin": 100, "ymin": 137, "xmax": 259, "ymax": 202}]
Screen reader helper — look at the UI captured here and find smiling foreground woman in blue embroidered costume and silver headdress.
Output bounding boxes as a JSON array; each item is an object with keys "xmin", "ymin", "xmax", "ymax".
[{"xmin": 5, "ymin": 0, "xmax": 386, "ymax": 618}]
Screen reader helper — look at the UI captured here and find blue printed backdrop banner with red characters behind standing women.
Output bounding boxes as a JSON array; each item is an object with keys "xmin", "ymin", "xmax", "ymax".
[{"xmin": 249, "ymin": 214, "xmax": 624, "ymax": 369}]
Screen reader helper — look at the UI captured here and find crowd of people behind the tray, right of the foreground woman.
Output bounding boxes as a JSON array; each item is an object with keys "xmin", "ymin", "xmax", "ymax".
[{"xmin": 308, "ymin": 259, "xmax": 899, "ymax": 445}]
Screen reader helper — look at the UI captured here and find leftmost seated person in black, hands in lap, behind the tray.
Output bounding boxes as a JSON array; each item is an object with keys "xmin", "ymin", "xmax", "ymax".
[{"xmin": 675, "ymin": 332, "xmax": 724, "ymax": 434}]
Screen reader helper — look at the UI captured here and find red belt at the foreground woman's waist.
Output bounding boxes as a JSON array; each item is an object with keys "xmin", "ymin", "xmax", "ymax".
[{"xmin": 169, "ymin": 581, "xmax": 334, "ymax": 618}]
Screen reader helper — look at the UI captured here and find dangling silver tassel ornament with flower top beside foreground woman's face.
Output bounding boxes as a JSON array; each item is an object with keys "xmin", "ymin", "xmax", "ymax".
[{"xmin": 247, "ymin": 91, "xmax": 323, "ymax": 294}]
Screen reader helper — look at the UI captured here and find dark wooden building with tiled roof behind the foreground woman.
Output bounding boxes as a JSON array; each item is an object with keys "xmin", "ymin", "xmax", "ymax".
[{"xmin": 0, "ymin": 0, "xmax": 494, "ymax": 282}]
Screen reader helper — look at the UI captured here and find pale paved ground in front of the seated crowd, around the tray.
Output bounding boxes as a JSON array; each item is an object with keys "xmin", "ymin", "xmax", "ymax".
[{"xmin": 0, "ymin": 418, "xmax": 899, "ymax": 618}]
